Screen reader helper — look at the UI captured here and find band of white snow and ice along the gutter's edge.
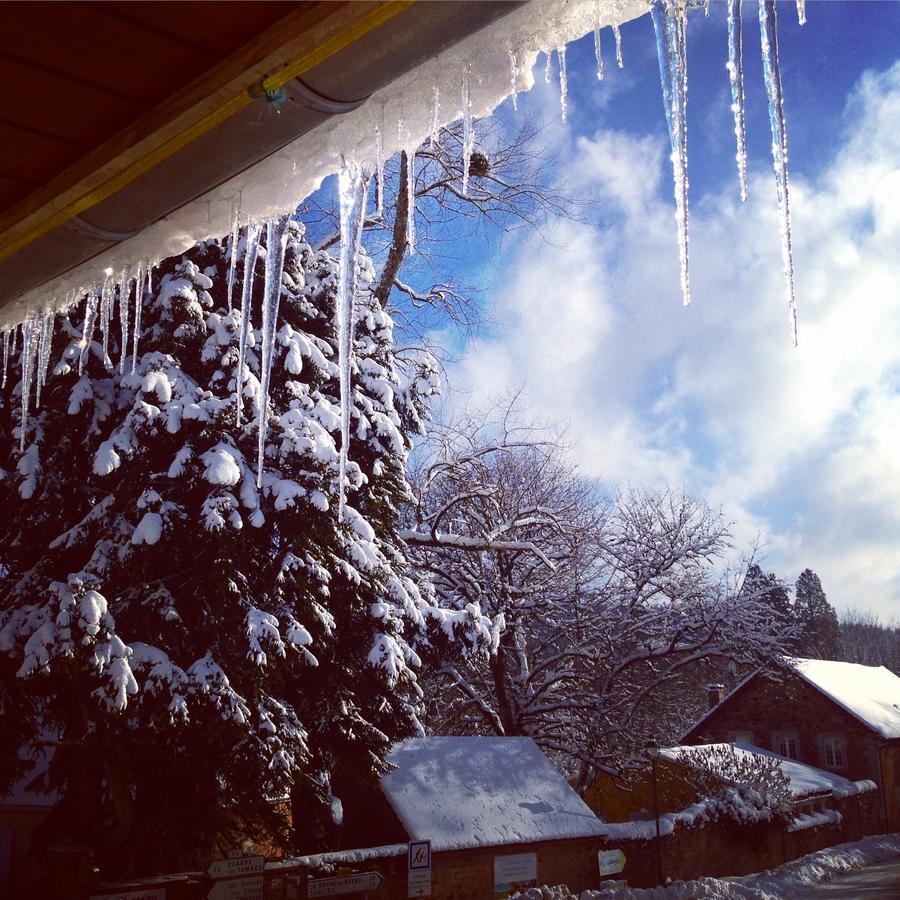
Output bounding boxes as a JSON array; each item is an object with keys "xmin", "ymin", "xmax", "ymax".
[{"xmin": 0, "ymin": 0, "xmax": 648, "ymax": 330}]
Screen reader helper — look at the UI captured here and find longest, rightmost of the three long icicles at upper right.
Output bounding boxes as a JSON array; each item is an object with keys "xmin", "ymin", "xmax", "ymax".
[{"xmin": 759, "ymin": 0, "xmax": 797, "ymax": 347}]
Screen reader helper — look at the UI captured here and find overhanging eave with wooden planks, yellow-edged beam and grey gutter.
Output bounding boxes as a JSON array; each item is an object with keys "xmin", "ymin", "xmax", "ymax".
[{"xmin": 0, "ymin": 0, "xmax": 519, "ymax": 309}]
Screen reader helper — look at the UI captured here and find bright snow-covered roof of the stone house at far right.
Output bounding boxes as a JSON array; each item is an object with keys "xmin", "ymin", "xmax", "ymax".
[{"xmin": 685, "ymin": 658, "xmax": 900, "ymax": 740}]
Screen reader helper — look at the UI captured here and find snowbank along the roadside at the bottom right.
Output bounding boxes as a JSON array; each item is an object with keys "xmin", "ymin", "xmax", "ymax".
[{"xmin": 514, "ymin": 834, "xmax": 900, "ymax": 900}]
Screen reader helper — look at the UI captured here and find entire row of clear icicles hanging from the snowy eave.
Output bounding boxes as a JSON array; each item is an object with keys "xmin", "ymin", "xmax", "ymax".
[{"xmin": 0, "ymin": 0, "xmax": 806, "ymax": 519}]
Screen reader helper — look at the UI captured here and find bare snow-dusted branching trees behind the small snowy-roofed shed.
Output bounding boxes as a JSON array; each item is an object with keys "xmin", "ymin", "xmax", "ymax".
[{"xmin": 402, "ymin": 414, "xmax": 789, "ymax": 783}]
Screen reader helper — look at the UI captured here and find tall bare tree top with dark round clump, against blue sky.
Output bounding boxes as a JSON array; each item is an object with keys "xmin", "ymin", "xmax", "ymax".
[{"xmin": 302, "ymin": 117, "xmax": 586, "ymax": 342}]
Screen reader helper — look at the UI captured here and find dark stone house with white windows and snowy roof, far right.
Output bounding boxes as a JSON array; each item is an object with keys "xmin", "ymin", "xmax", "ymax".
[{"xmin": 682, "ymin": 659, "xmax": 900, "ymax": 832}]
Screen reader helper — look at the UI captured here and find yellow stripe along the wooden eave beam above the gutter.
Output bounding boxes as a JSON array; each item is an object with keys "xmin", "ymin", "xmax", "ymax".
[{"xmin": 0, "ymin": 0, "xmax": 415, "ymax": 260}]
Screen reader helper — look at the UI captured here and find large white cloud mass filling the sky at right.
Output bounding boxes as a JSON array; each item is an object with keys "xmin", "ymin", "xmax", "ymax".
[{"xmin": 450, "ymin": 63, "xmax": 900, "ymax": 616}]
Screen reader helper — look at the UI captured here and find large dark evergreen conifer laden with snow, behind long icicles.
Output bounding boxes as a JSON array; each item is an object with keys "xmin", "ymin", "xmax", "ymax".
[{"xmin": 0, "ymin": 223, "xmax": 485, "ymax": 877}]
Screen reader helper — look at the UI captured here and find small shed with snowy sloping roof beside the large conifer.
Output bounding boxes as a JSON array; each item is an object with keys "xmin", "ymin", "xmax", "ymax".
[{"xmin": 345, "ymin": 737, "xmax": 606, "ymax": 900}]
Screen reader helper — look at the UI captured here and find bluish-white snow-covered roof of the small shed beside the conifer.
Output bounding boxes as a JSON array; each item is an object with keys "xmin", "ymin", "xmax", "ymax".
[{"xmin": 381, "ymin": 737, "xmax": 606, "ymax": 851}]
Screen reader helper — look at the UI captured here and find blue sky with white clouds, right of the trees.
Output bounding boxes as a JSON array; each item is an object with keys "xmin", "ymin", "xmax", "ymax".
[{"xmin": 320, "ymin": 0, "xmax": 900, "ymax": 619}]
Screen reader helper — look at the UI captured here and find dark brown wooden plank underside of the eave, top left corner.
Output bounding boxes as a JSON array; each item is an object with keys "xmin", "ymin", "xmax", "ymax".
[{"xmin": 0, "ymin": 2, "xmax": 300, "ymax": 214}]
